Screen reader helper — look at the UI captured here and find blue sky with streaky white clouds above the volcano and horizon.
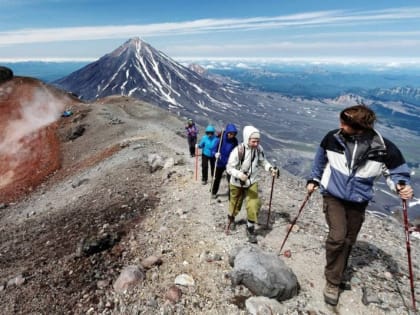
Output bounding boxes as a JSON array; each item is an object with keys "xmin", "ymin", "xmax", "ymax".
[{"xmin": 0, "ymin": 0, "xmax": 420, "ymax": 65}]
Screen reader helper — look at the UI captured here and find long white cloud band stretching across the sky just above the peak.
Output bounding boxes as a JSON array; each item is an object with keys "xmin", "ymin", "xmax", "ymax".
[{"xmin": 0, "ymin": 7, "xmax": 420, "ymax": 46}]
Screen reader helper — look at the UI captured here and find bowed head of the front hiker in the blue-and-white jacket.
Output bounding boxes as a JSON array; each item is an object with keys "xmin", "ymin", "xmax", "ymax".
[{"xmin": 340, "ymin": 104, "xmax": 376, "ymax": 135}]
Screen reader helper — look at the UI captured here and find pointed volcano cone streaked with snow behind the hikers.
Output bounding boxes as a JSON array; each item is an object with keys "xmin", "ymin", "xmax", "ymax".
[{"xmin": 54, "ymin": 38, "xmax": 241, "ymax": 119}]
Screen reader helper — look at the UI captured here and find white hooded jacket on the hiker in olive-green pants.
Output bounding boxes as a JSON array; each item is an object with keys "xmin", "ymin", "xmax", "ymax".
[{"xmin": 226, "ymin": 126, "xmax": 272, "ymax": 187}]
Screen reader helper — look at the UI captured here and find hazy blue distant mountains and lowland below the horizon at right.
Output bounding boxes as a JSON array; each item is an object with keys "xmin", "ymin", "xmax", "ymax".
[{"xmin": 200, "ymin": 64, "xmax": 420, "ymax": 138}]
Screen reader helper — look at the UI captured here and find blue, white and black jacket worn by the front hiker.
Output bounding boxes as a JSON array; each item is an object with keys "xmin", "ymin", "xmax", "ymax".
[{"xmin": 309, "ymin": 129, "xmax": 410, "ymax": 203}]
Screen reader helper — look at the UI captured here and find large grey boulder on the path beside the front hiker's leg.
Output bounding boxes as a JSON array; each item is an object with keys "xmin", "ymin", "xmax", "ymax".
[{"xmin": 229, "ymin": 246, "xmax": 299, "ymax": 301}]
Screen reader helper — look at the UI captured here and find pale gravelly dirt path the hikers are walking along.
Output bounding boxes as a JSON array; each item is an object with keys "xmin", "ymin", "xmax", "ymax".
[{"xmin": 113, "ymin": 132, "xmax": 418, "ymax": 315}]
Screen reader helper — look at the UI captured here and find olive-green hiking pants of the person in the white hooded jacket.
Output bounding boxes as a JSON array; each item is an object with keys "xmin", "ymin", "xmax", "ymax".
[{"xmin": 229, "ymin": 183, "xmax": 261, "ymax": 223}]
